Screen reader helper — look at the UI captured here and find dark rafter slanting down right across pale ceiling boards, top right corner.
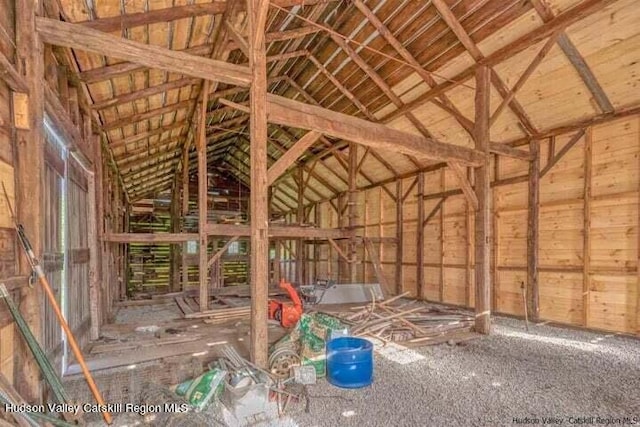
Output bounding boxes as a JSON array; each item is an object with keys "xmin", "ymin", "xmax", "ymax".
[{"xmin": 531, "ymin": 0, "xmax": 614, "ymax": 113}]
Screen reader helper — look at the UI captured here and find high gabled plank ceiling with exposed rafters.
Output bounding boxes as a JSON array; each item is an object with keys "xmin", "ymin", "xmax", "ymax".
[{"xmin": 47, "ymin": 0, "xmax": 640, "ymax": 211}]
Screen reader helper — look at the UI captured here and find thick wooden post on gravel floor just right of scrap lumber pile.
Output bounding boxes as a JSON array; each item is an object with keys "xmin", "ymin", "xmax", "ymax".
[{"xmin": 473, "ymin": 66, "xmax": 491, "ymax": 334}]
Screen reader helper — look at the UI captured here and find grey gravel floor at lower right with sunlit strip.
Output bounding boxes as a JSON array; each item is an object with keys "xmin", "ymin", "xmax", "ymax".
[{"xmin": 292, "ymin": 319, "xmax": 640, "ymax": 426}]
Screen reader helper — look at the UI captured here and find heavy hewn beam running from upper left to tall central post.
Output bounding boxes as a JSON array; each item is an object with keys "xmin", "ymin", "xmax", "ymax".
[{"xmin": 36, "ymin": 17, "xmax": 251, "ymax": 86}]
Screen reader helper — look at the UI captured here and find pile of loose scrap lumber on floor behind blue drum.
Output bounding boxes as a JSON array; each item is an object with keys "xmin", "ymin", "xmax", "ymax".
[{"xmin": 338, "ymin": 292, "xmax": 474, "ymax": 344}]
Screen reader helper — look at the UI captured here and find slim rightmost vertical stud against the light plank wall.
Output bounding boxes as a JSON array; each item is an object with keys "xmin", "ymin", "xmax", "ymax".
[{"xmin": 582, "ymin": 127, "xmax": 593, "ymax": 327}]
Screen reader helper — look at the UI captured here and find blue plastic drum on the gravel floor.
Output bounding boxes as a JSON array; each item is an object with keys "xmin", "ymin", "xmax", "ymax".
[{"xmin": 327, "ymin": 337, "xmax": 373, "ymax": 388}]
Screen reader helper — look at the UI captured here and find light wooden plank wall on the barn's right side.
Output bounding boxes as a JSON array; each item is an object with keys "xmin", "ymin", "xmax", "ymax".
[{"xmin": 316, "ymin": 117, "xmax": 640, "ymax": 333}]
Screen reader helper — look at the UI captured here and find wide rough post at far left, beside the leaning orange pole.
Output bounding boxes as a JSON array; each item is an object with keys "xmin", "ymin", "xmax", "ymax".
[{"xmin": 14, "ymin": 1, "xmax": 45, "ymax": 402}]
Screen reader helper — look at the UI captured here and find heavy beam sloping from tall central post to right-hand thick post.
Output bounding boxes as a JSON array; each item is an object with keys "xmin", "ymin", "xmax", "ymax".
[{"xmin": 267, "ymin": 95, "xmax": 483, "ymax": 166}]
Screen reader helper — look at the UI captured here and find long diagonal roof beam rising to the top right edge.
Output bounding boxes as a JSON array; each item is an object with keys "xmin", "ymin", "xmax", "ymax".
[{"xmin": 383, "ymin": 0, "xmax": 617, "ymax": 123}]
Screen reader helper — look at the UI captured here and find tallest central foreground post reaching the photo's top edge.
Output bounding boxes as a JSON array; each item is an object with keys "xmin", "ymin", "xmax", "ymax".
[{"xmin": 247, "ymin": 0, "xmax": 269, "ymax": 368}]
